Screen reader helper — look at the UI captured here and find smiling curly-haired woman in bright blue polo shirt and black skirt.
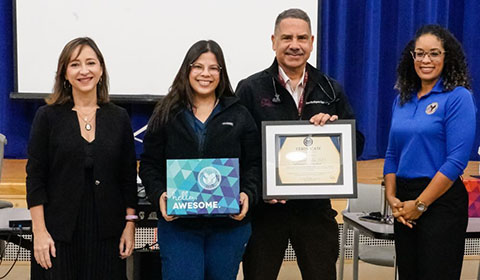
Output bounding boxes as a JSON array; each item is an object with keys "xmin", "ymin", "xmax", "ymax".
[{"xmin": 384, "ymin": 25, "xmax": 476, "ymax": 280}]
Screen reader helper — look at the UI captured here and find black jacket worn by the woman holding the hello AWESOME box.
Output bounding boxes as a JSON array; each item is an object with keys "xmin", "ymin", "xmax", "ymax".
[{"xmin": 140, "ymin": 97, "xmax": 261, "ymax": 228}]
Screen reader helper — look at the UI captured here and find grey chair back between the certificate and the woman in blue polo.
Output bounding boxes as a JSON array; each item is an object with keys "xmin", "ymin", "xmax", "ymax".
[{"xmin": 346, "ymin": 183, "xmax": 383, "ymax": 212}]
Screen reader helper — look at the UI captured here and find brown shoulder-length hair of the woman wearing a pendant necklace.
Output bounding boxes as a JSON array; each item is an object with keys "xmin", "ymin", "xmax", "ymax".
[{"xmin": 45, "ymin": 37, "xmax": 110, "ymax": 105}]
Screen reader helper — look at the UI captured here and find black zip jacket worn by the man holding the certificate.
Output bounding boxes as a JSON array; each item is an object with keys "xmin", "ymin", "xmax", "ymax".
[{"xmin": 236, "ymin": 59, "xmax": 365, "ymax": 209}]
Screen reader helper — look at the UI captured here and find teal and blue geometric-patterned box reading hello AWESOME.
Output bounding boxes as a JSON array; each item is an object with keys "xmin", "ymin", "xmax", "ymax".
[{"xmin": 167, "ymin": 158, "xmax": 240, "ymax": 216}]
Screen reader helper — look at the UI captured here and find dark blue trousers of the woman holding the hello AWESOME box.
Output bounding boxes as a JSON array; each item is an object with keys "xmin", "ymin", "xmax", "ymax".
[{"xmin": 158, "ymin": 218, "xmax": 252, "ymax": 280}]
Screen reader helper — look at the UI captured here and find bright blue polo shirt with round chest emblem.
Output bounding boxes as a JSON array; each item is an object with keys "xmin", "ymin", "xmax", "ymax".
[{"xmin": 383, "ymin": 79, "xmax": 476, "ymax": 181}]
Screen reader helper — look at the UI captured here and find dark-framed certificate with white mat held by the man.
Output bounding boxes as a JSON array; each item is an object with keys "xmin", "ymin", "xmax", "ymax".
[{"xmin": 262, "ymin": 120, "xmax": 357, "ymax": 199}]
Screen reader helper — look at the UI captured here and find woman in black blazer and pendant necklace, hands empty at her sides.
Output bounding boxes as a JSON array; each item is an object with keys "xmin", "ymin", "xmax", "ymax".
[{"xmin": 27, "ymin": 38, "xmax": 136, "ymax": 280}]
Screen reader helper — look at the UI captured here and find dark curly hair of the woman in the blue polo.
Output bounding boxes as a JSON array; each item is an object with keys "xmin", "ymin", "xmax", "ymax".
[{"xmin": 395, "ymin": 24, "xmax": 471, "ymax": 105}]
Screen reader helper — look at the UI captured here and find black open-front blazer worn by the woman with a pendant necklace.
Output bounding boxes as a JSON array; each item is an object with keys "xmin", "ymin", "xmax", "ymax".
[{"xmin": 27, "ymin": 103, "xmax": 137, "ymax": 242}]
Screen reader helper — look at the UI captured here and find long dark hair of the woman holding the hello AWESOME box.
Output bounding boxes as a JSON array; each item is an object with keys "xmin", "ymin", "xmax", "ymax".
[{"xmin": 149, "ymin": 40, "xmax": 234, "ymax": 129}]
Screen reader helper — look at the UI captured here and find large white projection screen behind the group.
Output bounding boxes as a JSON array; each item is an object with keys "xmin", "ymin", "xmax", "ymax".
[{"xmin": 16, "ymin": 0, "xmax": 318, "ymax": 95}]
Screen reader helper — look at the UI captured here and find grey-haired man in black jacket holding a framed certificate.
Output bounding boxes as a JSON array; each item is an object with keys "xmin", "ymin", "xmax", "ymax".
[{"xmin": 236, "ymin": 9, "xmax": 364, "ymax": 280}]
